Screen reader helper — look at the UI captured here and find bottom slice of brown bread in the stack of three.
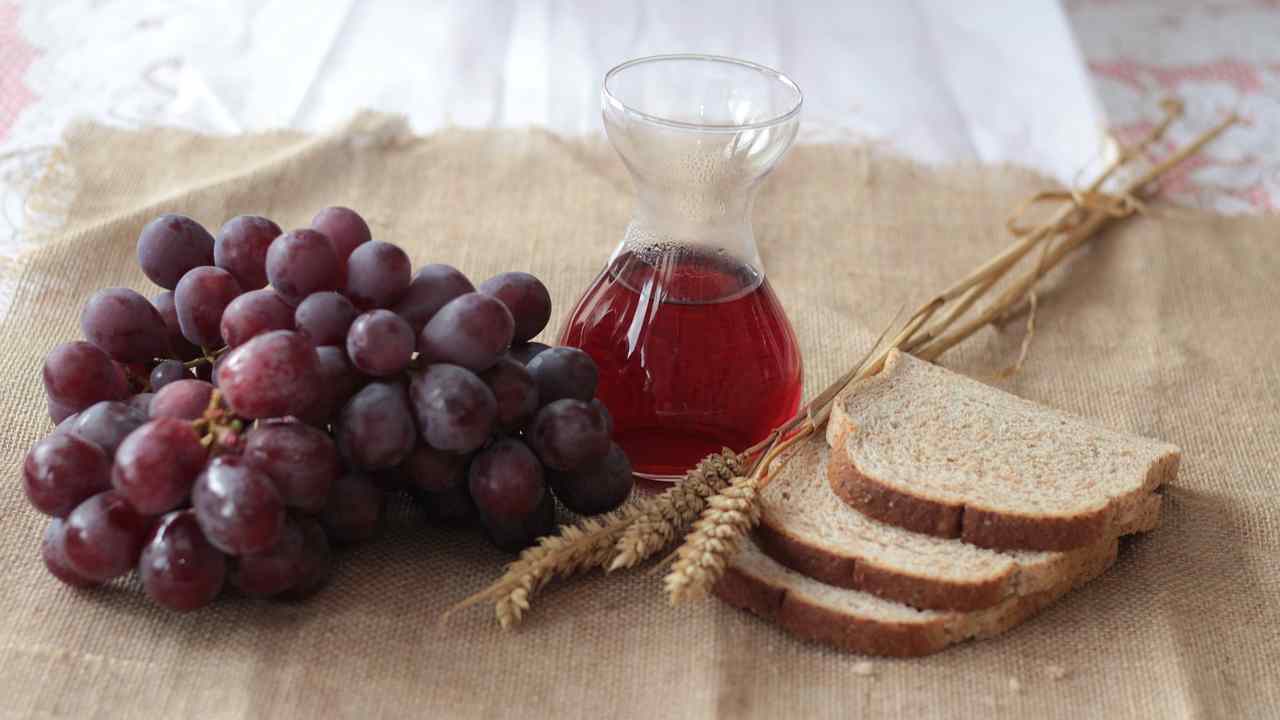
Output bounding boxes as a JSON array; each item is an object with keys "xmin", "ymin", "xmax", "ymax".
[{"xmin": 714, "ymin": 539, "xmax": 1116, "ymax": 657}]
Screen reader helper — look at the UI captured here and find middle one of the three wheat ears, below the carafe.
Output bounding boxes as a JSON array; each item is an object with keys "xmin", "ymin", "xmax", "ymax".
[{"xmin": 608, "ymin": 447, "xmax": 746, "ymax": 573}]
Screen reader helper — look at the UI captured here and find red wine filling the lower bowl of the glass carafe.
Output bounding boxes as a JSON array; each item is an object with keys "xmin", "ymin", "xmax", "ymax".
[{"xmin": 561, "ymin": 246, "xmax": 803, "ymax": 475}]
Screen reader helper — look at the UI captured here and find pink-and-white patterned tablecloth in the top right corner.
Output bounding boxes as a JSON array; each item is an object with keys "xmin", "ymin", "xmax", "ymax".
[{"xmin": 1066, "ymin": 0, "xmax": 1280, "ymax": 213}]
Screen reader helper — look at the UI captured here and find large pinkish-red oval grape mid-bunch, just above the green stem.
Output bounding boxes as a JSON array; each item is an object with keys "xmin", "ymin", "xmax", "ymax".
[{"xmin": 218, "ymin": 331, "xmax": 321, "ymax": 418}]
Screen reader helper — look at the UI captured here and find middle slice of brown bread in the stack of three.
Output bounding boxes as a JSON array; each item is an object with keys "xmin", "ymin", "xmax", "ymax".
[{"xmin": 756, "ymin": 437, "xmax": 1161, "ymax": 610}]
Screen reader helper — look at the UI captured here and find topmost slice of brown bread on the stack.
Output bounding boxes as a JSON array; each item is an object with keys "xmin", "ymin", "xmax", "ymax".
[{"xmin": 827, "ymin": 352, "xmax": 1181, "ymax": 550}]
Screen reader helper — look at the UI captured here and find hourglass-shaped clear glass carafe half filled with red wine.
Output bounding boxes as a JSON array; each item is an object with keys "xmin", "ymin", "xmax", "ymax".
[{"xmin": 561, "ymin": 55, "xmax": 803, "ymax": 479}]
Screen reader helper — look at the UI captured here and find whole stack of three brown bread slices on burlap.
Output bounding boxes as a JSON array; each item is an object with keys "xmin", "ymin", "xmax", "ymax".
[{"xmin": 716, "ymin": 352, "xmax": 1180, "ymax": 656}]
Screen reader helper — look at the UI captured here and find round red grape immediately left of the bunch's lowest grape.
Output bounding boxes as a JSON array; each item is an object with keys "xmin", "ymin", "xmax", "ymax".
[{"xmin": 63, "ymin": 491, "xmax": 151, "ymax": 583}]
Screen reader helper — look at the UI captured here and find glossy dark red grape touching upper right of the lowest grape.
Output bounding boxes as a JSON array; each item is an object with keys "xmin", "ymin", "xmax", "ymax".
[{"xmin": 191, "ymin": 455, "xmax": 284, "ymax": 555}]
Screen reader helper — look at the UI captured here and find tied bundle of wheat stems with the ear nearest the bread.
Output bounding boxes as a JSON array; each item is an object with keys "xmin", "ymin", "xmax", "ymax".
[{"xmin": 664, "ymin": 104, "xmax": 1236, "ymax": 605}]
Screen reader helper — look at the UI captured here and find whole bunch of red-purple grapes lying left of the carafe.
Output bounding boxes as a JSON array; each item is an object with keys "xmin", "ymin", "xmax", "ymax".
[{"xmin": 23, "ymin": 208, "xmax": 632, "ymax": 610}]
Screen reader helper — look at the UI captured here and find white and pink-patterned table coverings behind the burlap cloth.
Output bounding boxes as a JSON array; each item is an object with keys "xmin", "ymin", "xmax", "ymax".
[{"xmin": 0, "ymin": 0, "xmax": 1280, "ymax": 265}]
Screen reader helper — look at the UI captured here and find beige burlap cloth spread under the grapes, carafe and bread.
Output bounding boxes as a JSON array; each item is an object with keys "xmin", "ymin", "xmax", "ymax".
[{"xmin": 0, "ymin": 117, "xmax": 1280, "ymax": 719}]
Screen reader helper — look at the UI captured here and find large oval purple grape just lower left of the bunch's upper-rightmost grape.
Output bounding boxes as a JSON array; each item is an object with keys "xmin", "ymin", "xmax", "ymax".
[{"xmin": 417, "ymin": 292, "xmax": 515, "ymax": 373}]
